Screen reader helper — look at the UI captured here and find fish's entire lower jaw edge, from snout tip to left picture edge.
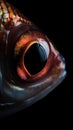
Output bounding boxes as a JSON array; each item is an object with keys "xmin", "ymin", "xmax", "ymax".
[{"xmin": 0, "ymin": 70, "xmax": 67, "ymax": 118}]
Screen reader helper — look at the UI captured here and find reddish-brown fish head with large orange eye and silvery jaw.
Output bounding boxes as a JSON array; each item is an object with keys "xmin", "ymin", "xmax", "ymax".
[{"xmin": 0, "ymin": 0, "xmax": 66, "ymax": 117}]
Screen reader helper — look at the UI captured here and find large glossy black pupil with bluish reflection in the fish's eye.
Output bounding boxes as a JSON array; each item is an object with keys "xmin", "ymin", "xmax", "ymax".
[{"xmin": 24, "ymin": 43, "xmax": 47, "ymax": 75}]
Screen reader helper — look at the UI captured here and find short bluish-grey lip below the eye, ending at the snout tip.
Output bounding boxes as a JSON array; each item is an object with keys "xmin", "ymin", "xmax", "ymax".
[{"xmin": 22, "ymin": 70, "xmax": 67, "ymax": 105}]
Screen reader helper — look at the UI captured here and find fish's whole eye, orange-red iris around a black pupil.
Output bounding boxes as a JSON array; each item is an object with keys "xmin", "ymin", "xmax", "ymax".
[{"xmin": 14, "ymin": 32, "xmax": 50, "ymax": 81}]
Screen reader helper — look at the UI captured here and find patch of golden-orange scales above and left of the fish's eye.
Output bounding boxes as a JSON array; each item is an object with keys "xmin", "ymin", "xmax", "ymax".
[{"xmin": 0, "ymin": 0, "xmax": 31, "ymax": 30}]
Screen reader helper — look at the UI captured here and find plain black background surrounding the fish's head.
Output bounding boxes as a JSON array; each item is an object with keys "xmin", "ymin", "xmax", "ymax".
[{"xmin": 1, "ymin": 0, "xmax": 73, "ymax": 129}]
